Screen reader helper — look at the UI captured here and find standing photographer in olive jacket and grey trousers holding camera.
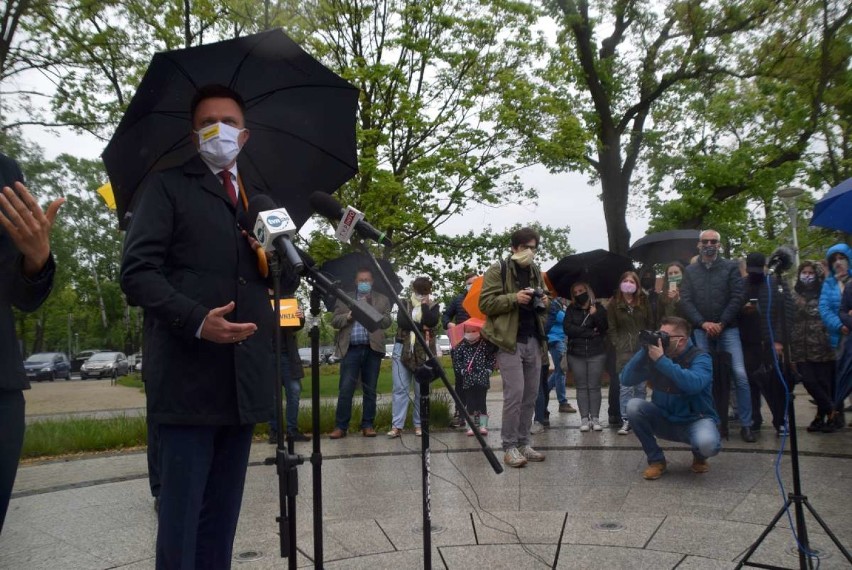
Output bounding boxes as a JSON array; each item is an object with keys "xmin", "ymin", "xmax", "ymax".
[{"xmin": 479, "ymin": 228, "xmax": 547, "ymax": 467}]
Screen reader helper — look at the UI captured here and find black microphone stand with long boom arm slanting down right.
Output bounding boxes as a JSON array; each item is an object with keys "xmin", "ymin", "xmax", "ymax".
[{"xmin": 356, "ymin": 240, "xmax": 503, "ymax": 569}]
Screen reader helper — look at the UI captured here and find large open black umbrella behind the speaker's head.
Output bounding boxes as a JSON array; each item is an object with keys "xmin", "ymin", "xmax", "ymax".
[{"xmin": 102, "ymin": 30, "xmax": 358, "ymax": 227}]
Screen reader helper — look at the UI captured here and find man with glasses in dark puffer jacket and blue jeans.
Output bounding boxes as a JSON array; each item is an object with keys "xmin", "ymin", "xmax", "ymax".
[{"xmin": 680, "ymin": 230, "xmax": 757, "ymax": 443}]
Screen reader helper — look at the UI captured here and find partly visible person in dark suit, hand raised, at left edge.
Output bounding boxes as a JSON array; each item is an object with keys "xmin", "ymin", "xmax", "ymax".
[{"xmin": 0, "ymin": 153, "xmax": 65, "ymax": 533}]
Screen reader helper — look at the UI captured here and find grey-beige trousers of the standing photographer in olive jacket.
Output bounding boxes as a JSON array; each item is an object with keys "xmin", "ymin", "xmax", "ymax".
[{"xmin": 497, "ymin": 338, "xmax": 541, "ymax": 451}]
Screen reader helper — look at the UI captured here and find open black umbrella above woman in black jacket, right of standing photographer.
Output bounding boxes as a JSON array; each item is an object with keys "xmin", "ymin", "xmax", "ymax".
[{"xmin": 547, "ymin": 249, "xmax": 633, "ymax": 299}]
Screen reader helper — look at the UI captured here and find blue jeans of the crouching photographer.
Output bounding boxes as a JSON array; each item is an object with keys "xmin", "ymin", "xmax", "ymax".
[{"xmin": 626, "ymin": 398, "xmax": 722, "ymax": 464}]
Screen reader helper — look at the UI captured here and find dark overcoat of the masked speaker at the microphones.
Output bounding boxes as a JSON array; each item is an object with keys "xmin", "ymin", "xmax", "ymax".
[{"xmin": 121, "ymin": 157, "xmax": 277, "ymax": 425}]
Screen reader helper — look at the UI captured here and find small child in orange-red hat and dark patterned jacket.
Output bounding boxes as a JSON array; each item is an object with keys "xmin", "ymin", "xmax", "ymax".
[{"xmin": 453, "ymin": 318, "xmax": 497, "ymax": 436}]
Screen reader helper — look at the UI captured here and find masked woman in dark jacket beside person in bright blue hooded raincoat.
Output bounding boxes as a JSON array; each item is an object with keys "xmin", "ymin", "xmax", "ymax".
[{"xmin": 790, "ymin": 261, "xmax": 843, "ymax": 433}]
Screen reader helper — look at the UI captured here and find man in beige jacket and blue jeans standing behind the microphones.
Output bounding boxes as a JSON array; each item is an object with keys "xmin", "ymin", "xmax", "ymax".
[{"xmin": 329, "ymin": 268, "xmax": 391, "ymax": 439}]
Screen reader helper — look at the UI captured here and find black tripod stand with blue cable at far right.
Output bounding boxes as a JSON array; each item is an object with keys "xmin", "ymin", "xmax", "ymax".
[{"xmin": 736, "ymin": 269, "xmax": 852, "ymax": 570}]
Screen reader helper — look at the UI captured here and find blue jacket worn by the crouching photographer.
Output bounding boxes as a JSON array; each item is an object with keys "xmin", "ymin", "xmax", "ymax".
[{"xmin": 621, "ymin": 341, "xmax": 719, "ymax": 424}]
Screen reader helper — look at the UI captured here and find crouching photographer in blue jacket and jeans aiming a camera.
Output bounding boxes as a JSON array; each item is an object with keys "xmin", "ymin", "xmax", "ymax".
[{"xmin": 621, "ymin": 317, "xmax": 721, "ymax": 480}]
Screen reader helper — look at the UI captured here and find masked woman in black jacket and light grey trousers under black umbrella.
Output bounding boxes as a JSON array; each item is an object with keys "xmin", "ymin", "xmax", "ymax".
[{"xmin": 562, "ymin": 282, "xmax": 609, "ymax": 432}]
